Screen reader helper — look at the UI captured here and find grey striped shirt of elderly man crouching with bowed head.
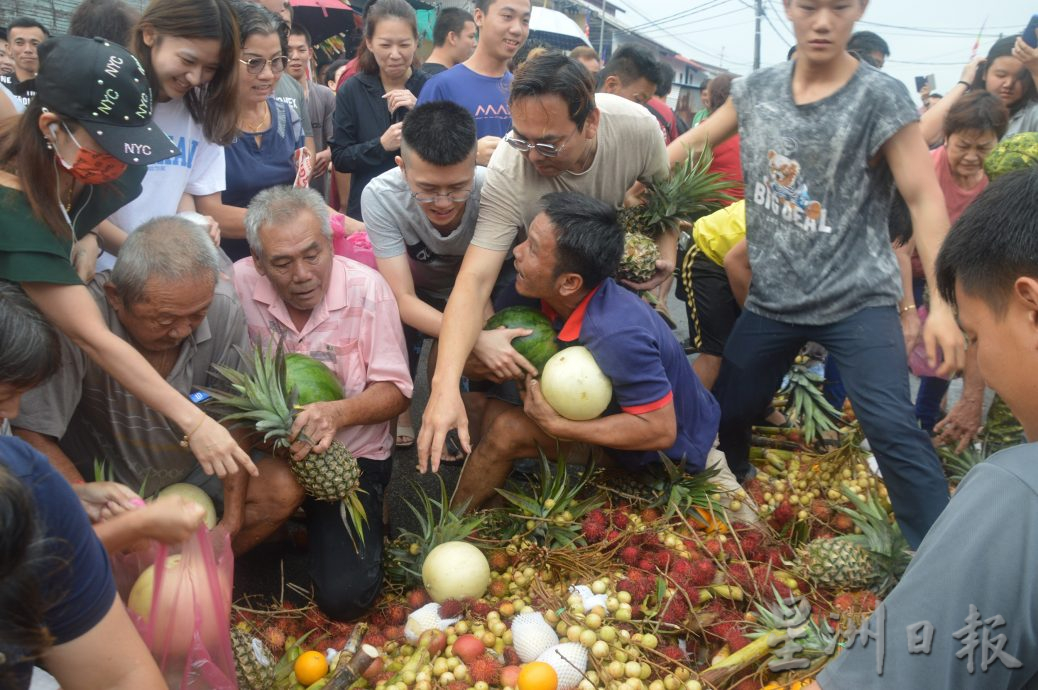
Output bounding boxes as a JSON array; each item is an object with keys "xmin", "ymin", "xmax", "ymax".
[{"xmin": 11, "ymin": 271, "xmax": 251, "ymax": 495}]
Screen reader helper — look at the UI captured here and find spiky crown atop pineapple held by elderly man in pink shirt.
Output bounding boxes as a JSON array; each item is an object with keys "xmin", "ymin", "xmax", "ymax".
[{"xmin": 203, "ymin": 340, "xmax": 297, "ymax": 447}]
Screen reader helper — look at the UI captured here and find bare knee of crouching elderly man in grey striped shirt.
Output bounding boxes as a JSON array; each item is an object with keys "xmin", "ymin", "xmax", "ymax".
[{"xmin": 231, "ymin": 458, "xmax": 303, "ymax": 555}]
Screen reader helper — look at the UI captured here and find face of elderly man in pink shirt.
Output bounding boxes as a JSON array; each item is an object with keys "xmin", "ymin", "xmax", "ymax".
[{"xmin": 255, "ymin": 211, "xmax": 333, "ymax": 312}]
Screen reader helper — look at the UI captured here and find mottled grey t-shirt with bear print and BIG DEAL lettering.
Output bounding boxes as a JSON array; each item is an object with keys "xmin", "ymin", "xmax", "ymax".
[{"xmin": 732, "ymin": 62, "xmax": 918, "ymax": 325}]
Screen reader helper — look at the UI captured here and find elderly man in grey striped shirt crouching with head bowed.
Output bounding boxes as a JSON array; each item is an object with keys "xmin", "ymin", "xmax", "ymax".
[{"xmin": 11, "ymin": 217, "xmax": 299, "ymax": 539}]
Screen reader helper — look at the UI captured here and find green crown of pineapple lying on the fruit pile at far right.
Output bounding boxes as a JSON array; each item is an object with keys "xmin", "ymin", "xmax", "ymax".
[{"xmin": 835, "ymin": 485, "xmax": 911, "ymax": 596}]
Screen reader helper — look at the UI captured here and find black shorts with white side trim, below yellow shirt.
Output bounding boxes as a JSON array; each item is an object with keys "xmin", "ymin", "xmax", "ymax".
[{"xmin": 681, "ymin": 246, "xmax": 741, "ymax": 357}]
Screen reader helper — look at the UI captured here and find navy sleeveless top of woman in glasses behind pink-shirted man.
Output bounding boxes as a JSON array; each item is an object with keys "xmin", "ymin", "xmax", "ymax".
[{"xmin": 220, "ymin": 98, "xmax": 305, "ymax": 261}]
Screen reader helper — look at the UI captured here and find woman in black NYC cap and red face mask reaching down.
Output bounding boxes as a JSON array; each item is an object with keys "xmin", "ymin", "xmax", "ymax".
[{"xmin": 0, "ymin": 36, "xmax": 255, "ymax": 477}]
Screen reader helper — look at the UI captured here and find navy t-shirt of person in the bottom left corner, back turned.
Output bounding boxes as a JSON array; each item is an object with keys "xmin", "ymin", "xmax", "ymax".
[{"xmin": 0, "ymin": 437, "xmax": 115, "ymax": 688}]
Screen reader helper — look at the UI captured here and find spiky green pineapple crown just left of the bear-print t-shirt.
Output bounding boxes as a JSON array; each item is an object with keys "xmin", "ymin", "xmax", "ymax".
[{"xmin": 632, "ymin": 143, "xmax": 735, "ymax": 237}]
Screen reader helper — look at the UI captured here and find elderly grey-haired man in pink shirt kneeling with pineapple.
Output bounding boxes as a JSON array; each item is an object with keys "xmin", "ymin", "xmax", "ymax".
[{"xmin": 235, "ymin": 187, "xmax": 412, "ymax": 620}]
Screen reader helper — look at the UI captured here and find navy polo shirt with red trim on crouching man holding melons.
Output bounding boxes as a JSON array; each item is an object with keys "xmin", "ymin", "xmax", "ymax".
[{"xmin": 542, "ymin": 278, "xmax": 720, "ymax": 472}]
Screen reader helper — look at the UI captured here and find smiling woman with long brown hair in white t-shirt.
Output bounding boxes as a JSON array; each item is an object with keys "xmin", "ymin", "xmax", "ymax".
[{"xmin": 98, "ymin": 0, "xmax": 245, "ymax": 270}]
